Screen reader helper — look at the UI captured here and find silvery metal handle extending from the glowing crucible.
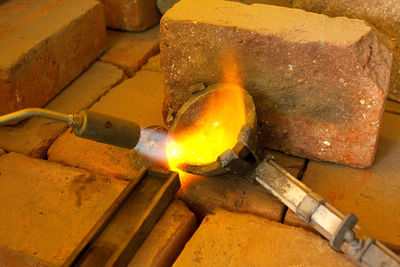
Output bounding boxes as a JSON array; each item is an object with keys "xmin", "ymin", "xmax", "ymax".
[{"xmin": 247, "ymin": 158, "xmax": 400, "ymax": 267}]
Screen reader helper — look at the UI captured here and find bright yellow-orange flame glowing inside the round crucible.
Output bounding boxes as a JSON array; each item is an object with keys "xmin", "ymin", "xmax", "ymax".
[{"xmin": 166, "ymin": 52, "xmax": 246, "ymax": 178}]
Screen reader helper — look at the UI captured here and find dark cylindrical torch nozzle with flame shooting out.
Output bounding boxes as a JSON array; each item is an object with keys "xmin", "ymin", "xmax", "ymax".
[{"xmin": 74, "ymin": 110, "xmax": 140, "ymax": 149}]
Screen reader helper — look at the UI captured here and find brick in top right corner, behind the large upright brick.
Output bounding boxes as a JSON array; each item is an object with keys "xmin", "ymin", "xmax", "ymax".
[{"xmin": 293, "ymin": 0, "xmax": 400, "ymax": 102}]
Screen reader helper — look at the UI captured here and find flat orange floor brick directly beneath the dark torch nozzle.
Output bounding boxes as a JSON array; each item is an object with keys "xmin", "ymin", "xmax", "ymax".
[{"xmin": 48, "ymin": 71, "xmax": 164, "ymax": 179}]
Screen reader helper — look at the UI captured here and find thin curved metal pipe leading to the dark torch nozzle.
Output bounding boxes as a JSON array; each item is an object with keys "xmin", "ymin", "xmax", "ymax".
[{"xmin": 0, "ymin": 108, "xmax": 74, "ymax": 125}]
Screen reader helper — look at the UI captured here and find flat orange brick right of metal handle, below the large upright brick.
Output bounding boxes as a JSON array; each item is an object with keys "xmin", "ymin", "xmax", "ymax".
[{"xmin": 285, "ymin": 113, "xmax": 400, "ymax": 253}]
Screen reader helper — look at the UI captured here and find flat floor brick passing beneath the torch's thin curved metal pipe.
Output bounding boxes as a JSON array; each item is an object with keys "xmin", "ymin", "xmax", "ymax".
[{"xmin": 0, "ymin": 62, "xmax": 124, "ymax": 158}]
